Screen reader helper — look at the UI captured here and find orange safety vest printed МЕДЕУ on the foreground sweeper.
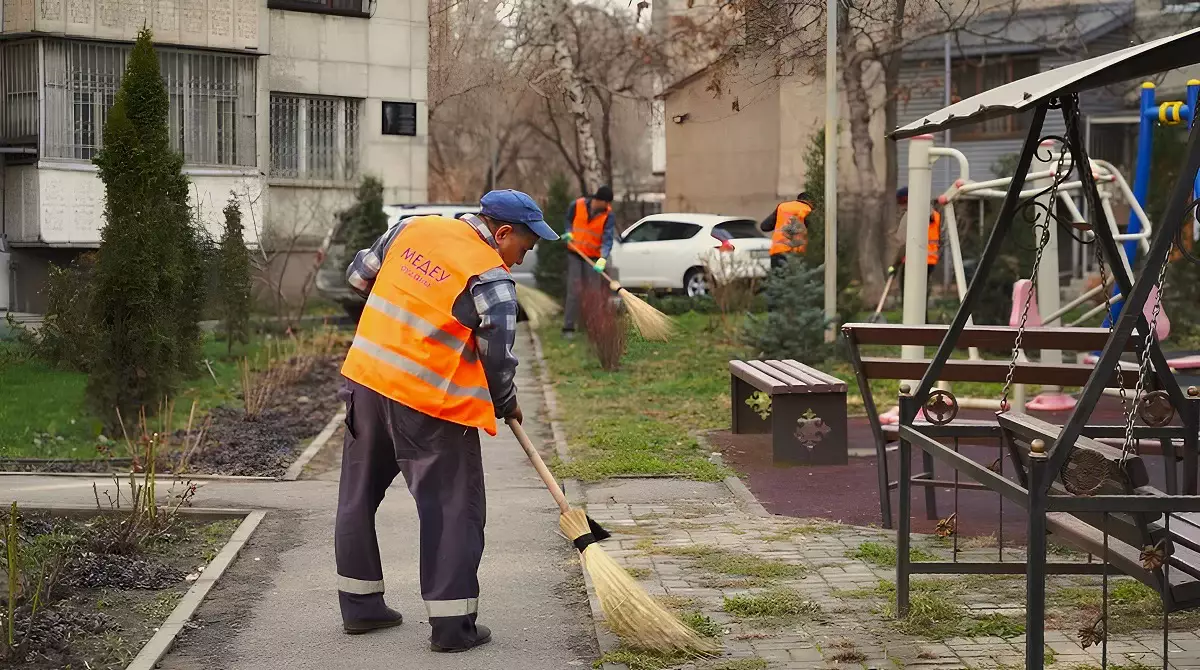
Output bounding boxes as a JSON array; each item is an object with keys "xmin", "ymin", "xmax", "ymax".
[{"xmin": 342, "ymin": 216, "xmax": 508, "ymax": 435}]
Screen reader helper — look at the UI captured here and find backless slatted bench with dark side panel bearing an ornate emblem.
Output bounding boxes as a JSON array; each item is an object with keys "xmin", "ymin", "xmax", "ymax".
[{"xmin": 730, "ymin": 359, "xmax": 847, "ymax": 465}]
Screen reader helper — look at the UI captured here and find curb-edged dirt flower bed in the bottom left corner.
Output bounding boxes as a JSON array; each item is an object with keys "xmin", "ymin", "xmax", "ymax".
[{"xmin": 0, "ymin": 506, "xmax": 240, "ymax": 670}]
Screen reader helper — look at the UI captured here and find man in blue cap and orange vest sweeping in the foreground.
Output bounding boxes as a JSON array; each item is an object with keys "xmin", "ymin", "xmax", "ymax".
[{"xmin": 334, "ymin": 190, "xmax": 558, "ymax": 652}]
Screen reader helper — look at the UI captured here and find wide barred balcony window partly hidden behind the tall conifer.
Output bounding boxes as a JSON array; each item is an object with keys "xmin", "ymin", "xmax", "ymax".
[{"xmin": 46, "ymin": 41, "xmax": 257, "ymax": 167}]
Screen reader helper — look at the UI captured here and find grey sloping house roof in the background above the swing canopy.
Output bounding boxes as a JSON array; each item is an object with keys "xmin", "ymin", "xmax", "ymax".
[{"xmin": 904, "ymin": 1, "xmax": 1134, "ymax": 60}]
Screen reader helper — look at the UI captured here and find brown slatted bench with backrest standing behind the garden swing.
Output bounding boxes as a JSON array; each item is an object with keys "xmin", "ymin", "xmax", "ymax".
[{"xmin": 841, "ymin": 323, "xmax": 1176, "ymax": 528}]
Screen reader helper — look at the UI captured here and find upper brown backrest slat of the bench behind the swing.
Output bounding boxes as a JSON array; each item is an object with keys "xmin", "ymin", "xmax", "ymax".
[{"xmin": 841, "ymin": 323, "xmax": 1139, "ymax": 352}]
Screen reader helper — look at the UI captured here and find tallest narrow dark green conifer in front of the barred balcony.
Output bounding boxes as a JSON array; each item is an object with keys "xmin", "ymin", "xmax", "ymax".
[{"xmin": 88, "ymin": 29, "xmax": 195, "ymax": 429}]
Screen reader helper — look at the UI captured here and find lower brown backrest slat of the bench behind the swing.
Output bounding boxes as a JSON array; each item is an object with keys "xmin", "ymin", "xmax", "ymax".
[{"xmin": 863, "ymin": 358, "xmax": 1138, "ymax": 388}]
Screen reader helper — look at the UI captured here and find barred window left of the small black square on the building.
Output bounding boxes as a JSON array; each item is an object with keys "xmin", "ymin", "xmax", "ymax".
[{"xmin": 271, "ymin": 92, "xmax": 362, "ymax": 181}]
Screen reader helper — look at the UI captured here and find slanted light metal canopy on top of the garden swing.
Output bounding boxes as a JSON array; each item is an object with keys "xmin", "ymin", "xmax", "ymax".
[{"xmin": 890, "ymin": 28, "xmax": 1200, "ymax": 139}]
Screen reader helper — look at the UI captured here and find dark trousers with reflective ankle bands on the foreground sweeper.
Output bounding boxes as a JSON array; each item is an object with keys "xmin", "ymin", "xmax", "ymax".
[{"xmin": 334, "ymin": 379, "xmax": 486, "ymax": 647}]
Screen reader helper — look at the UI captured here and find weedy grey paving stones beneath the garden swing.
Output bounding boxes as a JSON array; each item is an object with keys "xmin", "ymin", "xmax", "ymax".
[{"xmin": 588, "ymin": 484, "xmax": 1200, "ymax": 670}]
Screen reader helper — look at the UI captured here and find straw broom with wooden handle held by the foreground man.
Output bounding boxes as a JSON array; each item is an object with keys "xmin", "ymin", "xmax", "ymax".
[{"xmin": 508, "ymin": 419, "xmax": 719, "ymax": 656}]
